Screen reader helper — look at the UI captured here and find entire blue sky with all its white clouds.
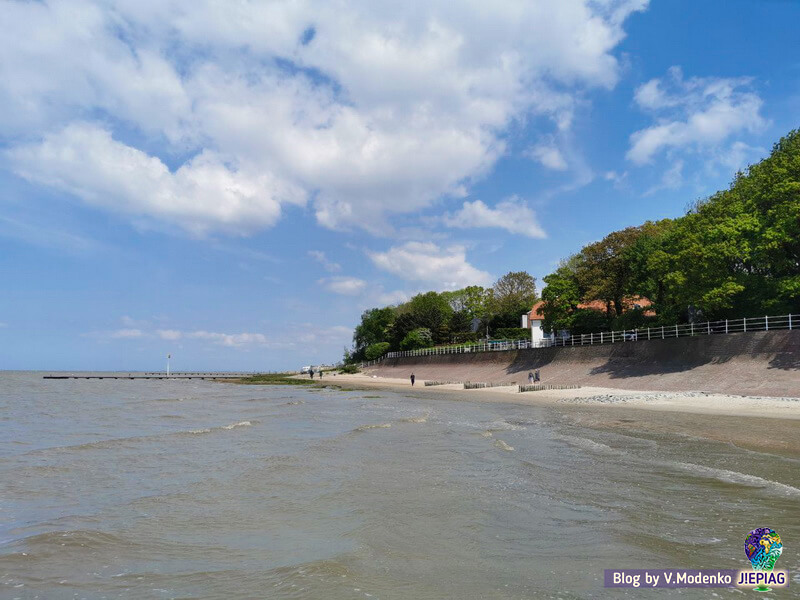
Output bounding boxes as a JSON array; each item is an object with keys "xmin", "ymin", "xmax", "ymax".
[{"xmin": 0, "ymin": 0, "xmax": 800, "ymax": 370}]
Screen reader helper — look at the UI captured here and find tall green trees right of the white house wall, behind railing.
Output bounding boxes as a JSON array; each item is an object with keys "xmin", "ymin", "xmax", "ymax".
[{"xmin": 541, "ymin": 130, "xmax": 800, "ymax": 334}]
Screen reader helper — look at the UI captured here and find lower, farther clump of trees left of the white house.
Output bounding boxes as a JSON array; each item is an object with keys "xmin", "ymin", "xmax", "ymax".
[{"xmin": 345, "ymin": 271, "xmax": 537, "ymax": 362}]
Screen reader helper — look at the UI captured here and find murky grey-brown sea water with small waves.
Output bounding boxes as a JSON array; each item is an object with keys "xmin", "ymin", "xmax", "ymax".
[{"xmin": 0, "ymin": 372, "xmax": 800, "ymax": 600}]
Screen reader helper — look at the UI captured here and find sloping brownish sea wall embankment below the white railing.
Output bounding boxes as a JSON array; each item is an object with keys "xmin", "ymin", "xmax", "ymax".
[{"xmin": 366, "ymin": 330, "xmax": 800, "ymax": 397}]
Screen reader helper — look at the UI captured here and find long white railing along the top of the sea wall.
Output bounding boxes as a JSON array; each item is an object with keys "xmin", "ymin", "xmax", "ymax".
[{"xmin": 382, "ymin": 315, "xmax": 800, "ymax": 364}]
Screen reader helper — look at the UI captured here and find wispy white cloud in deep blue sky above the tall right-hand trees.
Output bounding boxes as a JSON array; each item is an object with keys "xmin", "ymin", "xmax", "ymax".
[{"xmin": 627, "ymin": 67, "xmax": 766, "ymax": 165}]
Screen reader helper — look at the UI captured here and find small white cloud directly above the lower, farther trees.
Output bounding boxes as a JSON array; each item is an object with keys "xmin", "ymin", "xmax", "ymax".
[{"xmin": 368, "ymin": 242, "xmax": 492, "ymax": 290}]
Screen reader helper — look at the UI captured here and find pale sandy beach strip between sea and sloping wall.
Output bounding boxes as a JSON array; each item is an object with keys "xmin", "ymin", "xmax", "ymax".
[{"xmin": 327, "ymin": 374, "xmax": 800, "ymax": 457}]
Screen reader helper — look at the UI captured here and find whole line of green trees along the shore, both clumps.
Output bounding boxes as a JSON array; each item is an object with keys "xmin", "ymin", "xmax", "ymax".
[{"xmin": 345, "ymin": 130, "xmax": 800, "ymax": 361}]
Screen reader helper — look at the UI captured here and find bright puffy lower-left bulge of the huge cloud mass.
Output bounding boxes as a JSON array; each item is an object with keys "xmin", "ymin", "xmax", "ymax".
[{"xmin": 7, "ymin": 123, "xmax": 305, "ymax": 233}]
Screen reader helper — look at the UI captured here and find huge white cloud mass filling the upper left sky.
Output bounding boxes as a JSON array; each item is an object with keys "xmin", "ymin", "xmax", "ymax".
[{"xmin": 0, "ymin": 0, "xmax": 647, "ymax": 233}]
